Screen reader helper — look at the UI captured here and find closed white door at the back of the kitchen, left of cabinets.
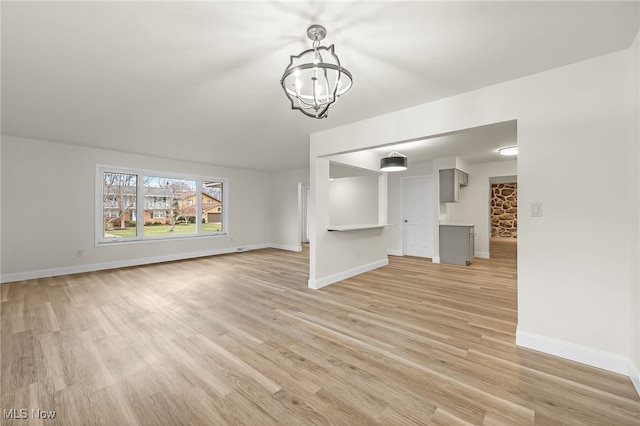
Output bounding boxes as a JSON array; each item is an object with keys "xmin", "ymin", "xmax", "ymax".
[{"xmin": 402, "ymin": 176, "xmax": 433, "ymax": 257}]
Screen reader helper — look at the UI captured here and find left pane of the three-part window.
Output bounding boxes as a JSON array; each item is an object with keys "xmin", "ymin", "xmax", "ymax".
[{"xmin": 102, "ymin": 172, "xmax": 137, "ymax": 239}]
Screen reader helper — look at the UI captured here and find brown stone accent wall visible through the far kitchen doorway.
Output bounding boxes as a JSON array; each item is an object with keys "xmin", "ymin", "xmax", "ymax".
[{"xmin": 491, "ymin": 182, "xmax": 518, "ymax": 238}]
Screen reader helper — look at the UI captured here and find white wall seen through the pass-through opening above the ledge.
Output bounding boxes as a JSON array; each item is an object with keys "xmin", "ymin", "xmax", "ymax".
[{"xmin": 329, "ymin": 176, "xmax": 378, "ymax": 226}]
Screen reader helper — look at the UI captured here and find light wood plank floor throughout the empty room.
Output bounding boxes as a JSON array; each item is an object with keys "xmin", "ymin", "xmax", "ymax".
[{"xmin": 1, "ymin": 241, "xmax": 640, "ymax": 426}]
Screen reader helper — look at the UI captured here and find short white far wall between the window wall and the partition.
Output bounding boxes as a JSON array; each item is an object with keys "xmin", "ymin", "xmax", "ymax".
[{"xmin": 271, "ymin": 168, "xmax": 309, "ymax": 251}]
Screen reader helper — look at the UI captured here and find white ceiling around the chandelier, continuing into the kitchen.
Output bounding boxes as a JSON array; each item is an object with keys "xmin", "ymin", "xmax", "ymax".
[{"xmin": 1, "ymin": 1, "xmax": 640, "ymax": 171}]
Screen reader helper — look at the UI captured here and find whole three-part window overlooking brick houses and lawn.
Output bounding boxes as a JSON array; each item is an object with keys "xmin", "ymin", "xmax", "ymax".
[{"xmin": 96, "ymin": 166, "xmax": 227, "ymax": 243}]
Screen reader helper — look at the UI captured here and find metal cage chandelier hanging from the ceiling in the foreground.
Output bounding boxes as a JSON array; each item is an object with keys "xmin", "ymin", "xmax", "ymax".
[{"xmin": 280, "ymin": 25, "xmax": 353, "ymax": 118}]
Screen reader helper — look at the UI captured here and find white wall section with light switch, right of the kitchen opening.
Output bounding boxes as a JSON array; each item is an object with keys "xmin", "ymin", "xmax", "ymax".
[{"xmin": 518, "ymin": 52, "xmax": 638, "ymax": 372}]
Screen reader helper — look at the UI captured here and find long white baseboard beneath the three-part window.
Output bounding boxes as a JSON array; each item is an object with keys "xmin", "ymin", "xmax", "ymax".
[{"xmin": 0, "ymin": 244, "xmax": 271, "ymax": 283}]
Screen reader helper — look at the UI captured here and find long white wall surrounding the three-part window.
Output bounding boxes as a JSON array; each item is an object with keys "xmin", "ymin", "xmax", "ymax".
[{"xmin": 1, "ymin": 136, "xmax": 271, "ymax": 282}]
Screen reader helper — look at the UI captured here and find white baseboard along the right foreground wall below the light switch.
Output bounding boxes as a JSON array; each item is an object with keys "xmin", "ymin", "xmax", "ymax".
[{"xmin": 516, "ymin": 330, "xmax": 637, "ymax": 376}]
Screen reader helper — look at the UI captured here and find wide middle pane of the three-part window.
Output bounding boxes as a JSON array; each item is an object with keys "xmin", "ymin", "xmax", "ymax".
[{"xmin": 144, "ymin": 176, "xmax": 196, "ymax": 236}]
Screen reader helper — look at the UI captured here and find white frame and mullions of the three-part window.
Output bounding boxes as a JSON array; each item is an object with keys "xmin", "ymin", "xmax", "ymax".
[{"xmin": 95, "ymin": 164, "xmax": 229, "ymax": 246}]
